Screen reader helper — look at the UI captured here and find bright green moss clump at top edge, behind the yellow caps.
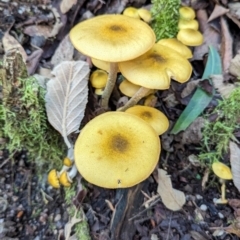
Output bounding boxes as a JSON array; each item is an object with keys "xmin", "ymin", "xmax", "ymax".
[{"xmin": 151, "ymin": 0, "xmax": 180, "ymax": 41}]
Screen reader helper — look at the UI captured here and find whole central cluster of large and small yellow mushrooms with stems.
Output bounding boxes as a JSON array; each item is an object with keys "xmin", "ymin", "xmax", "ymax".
[{"xmin": 48, "ymin": 4, "xmax": 199, "ymax": 188}]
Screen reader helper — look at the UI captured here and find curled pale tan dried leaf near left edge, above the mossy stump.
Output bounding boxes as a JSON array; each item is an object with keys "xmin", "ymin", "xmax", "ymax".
[{"xmin": 2, "ymin": 32, "xmax": 27, "ymax": 62}]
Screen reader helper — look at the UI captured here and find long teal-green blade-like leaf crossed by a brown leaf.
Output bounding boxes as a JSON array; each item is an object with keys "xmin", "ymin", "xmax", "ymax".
[{"xmin": 170, "ymin": 46, "xmax": 222, "ymax": 134}]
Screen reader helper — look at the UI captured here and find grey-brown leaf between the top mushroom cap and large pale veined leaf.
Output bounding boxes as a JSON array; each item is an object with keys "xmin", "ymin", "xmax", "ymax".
[{"xmin": 51, "ymin": 35, "xmax": 74, "ymax": 66}]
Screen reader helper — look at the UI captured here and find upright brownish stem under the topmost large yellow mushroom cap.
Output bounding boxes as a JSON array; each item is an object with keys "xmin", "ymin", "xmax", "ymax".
[{"xmin": 101, "ymin": 63, "xmax": 118, "ymax": 109}]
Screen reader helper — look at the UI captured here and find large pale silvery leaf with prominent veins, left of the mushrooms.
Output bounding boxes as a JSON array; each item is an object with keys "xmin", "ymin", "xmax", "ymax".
[{"xmin": 45, "ymin": 61, "xmax": 90, "ymax": 148}]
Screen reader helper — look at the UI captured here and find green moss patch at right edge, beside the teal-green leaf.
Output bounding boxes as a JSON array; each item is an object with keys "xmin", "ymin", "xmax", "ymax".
[{"xmin": 199, "ymin": 87, "xmax": 240, "ymax": 164}]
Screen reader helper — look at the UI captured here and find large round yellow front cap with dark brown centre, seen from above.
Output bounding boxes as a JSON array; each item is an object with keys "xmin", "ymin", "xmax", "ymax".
[{"xmin": 74, "ymin": 112, "xmax": 160, "ymax": 188}]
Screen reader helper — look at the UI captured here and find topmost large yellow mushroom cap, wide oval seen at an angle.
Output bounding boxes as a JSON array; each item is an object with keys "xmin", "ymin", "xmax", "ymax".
[{"xmin": 70, "ymin": 14, "xmax": 156, "ymax": 62}]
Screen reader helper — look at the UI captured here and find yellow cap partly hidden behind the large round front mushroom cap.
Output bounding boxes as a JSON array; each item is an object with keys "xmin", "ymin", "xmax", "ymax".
[{"xmin": 125, "ymin": 105, "xmax": 169, "ymax": 135}]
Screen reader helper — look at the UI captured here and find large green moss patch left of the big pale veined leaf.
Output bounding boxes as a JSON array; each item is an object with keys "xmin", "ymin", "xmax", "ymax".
[{"xmin": 0, "ymin": 56, "xmax": 66, "ymax": 173}]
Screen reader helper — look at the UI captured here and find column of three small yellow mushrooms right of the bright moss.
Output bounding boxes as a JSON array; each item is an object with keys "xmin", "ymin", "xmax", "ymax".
[{"xmin": 177, "ymin": 7, "xmax": 203, "ymax": 46}]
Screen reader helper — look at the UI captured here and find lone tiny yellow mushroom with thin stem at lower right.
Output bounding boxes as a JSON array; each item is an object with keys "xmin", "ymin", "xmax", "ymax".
[{"xmin": 212, "ymin": 162, "xmax": 232, "ymax": 204}]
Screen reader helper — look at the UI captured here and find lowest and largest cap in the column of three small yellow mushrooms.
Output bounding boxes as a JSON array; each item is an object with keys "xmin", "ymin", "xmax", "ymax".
[{"xmin": 177, "ymin": 28, "xmax": 203, "ymax": 46}]
